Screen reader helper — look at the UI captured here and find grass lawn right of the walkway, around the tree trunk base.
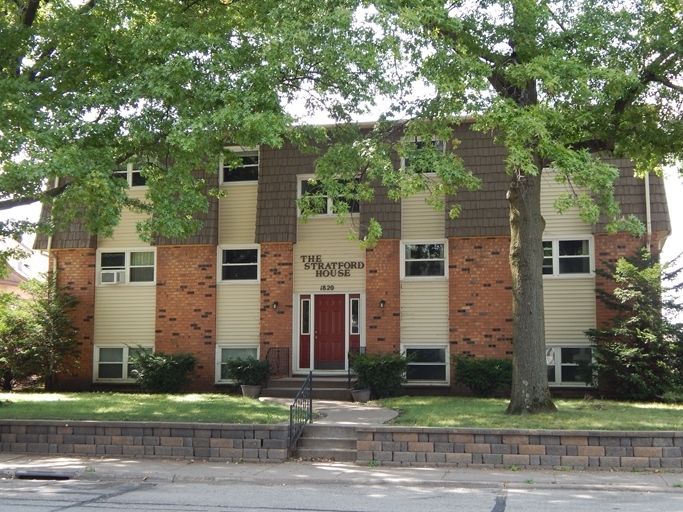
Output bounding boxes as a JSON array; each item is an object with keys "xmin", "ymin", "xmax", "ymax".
[{"xmin": 377, "ymin": 397, "xmax": 683, "ymax": 430}]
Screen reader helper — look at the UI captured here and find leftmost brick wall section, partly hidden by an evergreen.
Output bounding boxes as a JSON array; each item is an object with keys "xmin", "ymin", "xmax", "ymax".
[{"xmin": 50, "ymin": 249, "xmax": 96, "ymax": 390}]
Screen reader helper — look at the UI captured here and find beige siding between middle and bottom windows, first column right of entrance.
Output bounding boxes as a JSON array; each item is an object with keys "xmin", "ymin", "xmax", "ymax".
[{"xmin": 401, "ymin": 280, "xmax": 448, "ymax": 345}]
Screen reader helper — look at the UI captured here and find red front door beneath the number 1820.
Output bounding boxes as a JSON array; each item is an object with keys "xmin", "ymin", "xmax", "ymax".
[{"xmin": 313, "ymin": 295, "xmax": 346, "ymax": 370}]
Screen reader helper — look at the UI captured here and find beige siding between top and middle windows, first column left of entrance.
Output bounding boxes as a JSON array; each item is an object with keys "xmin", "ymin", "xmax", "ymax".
[{"xmin": 218, "ymin": 182, "xmax": 258, "ymax": 245}]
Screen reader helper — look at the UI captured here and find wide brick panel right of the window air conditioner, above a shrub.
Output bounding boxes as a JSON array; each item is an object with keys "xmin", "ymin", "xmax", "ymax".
[{"xmin": 155, "ymin": 245, "xmax": 216, "ymax": 390}]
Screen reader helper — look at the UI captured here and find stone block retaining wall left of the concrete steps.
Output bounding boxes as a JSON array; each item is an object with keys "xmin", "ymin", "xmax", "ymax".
[{"xmin": 0, "ymin": 420, "xmax": 290, "ymax": 462}]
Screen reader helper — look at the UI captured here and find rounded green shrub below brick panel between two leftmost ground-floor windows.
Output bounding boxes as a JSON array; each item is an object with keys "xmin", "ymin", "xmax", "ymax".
[{"xmin": 132, "ymin": 349, "xmax": 197, "ymax": 393}]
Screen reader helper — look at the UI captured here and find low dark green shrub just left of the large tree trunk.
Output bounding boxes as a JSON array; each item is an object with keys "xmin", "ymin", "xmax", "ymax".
[{"xmin": 453, "ymin": 355, "xmax": 512, "ymax": 397}]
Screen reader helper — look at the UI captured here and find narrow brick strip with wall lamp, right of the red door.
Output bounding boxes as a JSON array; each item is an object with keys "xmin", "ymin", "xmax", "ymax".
[{"xmin": 365, "ymin": 240, "xmax": 401, "ymax": 352}]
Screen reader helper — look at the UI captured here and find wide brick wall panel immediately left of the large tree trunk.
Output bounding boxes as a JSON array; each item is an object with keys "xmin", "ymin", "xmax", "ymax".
[{"xmin": 448, "ymin": 237, "xmax": 512, "ymax": 358}]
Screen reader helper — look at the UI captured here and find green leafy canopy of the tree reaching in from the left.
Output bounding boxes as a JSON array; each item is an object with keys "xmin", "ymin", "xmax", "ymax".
[{"xmin": 0, "ymin": 0, "xmax": 389, "ymax": 244}]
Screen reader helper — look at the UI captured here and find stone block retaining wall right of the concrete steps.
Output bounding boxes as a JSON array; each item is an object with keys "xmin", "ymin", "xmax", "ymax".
[{"xmin": 357, "ymin": 426, "xmax": 683, "ymax": 470}]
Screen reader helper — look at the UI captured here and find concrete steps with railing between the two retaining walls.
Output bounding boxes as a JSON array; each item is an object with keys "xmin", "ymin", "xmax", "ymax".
[{"xmin": 294, "ymin": 423, "xmax": 358, "ymax": 462}]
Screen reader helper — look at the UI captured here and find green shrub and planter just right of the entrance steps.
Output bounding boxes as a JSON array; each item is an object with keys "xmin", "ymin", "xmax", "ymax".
[{"xmin": 351, "ymin": 354, "xmax": 410, "ymax": 398}]
